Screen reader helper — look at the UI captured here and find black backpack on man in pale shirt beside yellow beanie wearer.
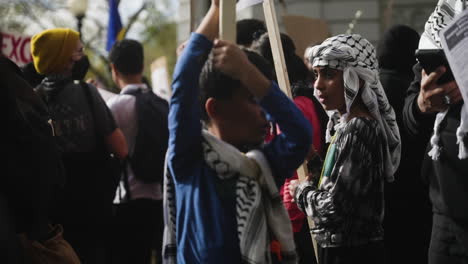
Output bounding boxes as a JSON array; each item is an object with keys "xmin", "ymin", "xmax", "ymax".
[{"xmin": 123, "ymin": 89, "xmax": 169, "ymax": 183}]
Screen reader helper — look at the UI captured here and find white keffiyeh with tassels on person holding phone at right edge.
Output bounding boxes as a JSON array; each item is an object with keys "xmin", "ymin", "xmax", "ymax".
[{"xmin": 419, "ymin": 0, "xmax": 468, "ymax": 160}]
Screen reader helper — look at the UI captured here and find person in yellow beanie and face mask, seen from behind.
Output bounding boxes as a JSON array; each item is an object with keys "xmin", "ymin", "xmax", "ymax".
[{"xmin": 31, "ymin": 28, "xmax": 128, "ymax": 263}]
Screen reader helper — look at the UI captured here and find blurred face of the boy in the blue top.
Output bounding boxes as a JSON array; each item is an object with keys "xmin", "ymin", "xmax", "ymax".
[{"xmin": 221, "ymin": 86, "xmax": 269, "ymax": 146}]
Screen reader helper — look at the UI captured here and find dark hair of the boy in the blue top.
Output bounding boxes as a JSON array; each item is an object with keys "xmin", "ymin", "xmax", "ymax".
[{"xmin": 199, "ymin": 49, "xmax": 273, "ymax": 121}]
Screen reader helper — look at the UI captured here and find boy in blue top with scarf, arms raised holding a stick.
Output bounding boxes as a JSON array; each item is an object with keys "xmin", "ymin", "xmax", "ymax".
[{"xmin": 163, "ymin": 0, "xmax": 311, "ymax": 264}]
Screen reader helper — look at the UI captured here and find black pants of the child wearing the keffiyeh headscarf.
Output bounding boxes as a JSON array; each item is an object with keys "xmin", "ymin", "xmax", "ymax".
[{"xmin": 318, "ymin": 241, "xmax": 385, "ymax": 264}]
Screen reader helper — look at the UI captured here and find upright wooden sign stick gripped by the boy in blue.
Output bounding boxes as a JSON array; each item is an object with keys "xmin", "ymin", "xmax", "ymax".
[{"xmin": 219, "ymin": 0, "xmax": 236, "ymax": 43}]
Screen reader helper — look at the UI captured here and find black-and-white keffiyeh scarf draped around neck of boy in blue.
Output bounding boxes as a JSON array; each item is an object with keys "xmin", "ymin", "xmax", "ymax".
[{"xmin": 163, "ymin": 131, "xmax": 297, "ymax": 264}]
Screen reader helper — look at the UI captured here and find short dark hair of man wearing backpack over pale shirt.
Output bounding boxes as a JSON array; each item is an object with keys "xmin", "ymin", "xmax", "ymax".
[{"xmin": 109, "ymin": 39, "xmax": 143, "ymax": 75}]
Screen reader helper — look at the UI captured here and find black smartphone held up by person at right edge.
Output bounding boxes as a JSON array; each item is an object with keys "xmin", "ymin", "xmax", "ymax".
[{"xmin": 415, "ymin": 49, "xmax": 454, "ymax": 84}]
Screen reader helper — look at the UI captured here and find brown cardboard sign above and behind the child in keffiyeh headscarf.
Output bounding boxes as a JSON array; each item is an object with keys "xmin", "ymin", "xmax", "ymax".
[{"xmin": 283, "ymin": 16, "xmax": 330, "ymax": 58}]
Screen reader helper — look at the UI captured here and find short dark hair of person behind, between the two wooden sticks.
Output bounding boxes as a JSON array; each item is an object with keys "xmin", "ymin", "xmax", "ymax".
[{"xmin": 236, "ymin": 18, "xmax": 267, "ymax": 47}]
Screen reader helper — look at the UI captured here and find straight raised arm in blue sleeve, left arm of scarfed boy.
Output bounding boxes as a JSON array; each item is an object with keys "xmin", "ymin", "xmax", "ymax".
[{"xmin": 168, "ymin": 0, "xmax": 219, "ymax": 179}]
